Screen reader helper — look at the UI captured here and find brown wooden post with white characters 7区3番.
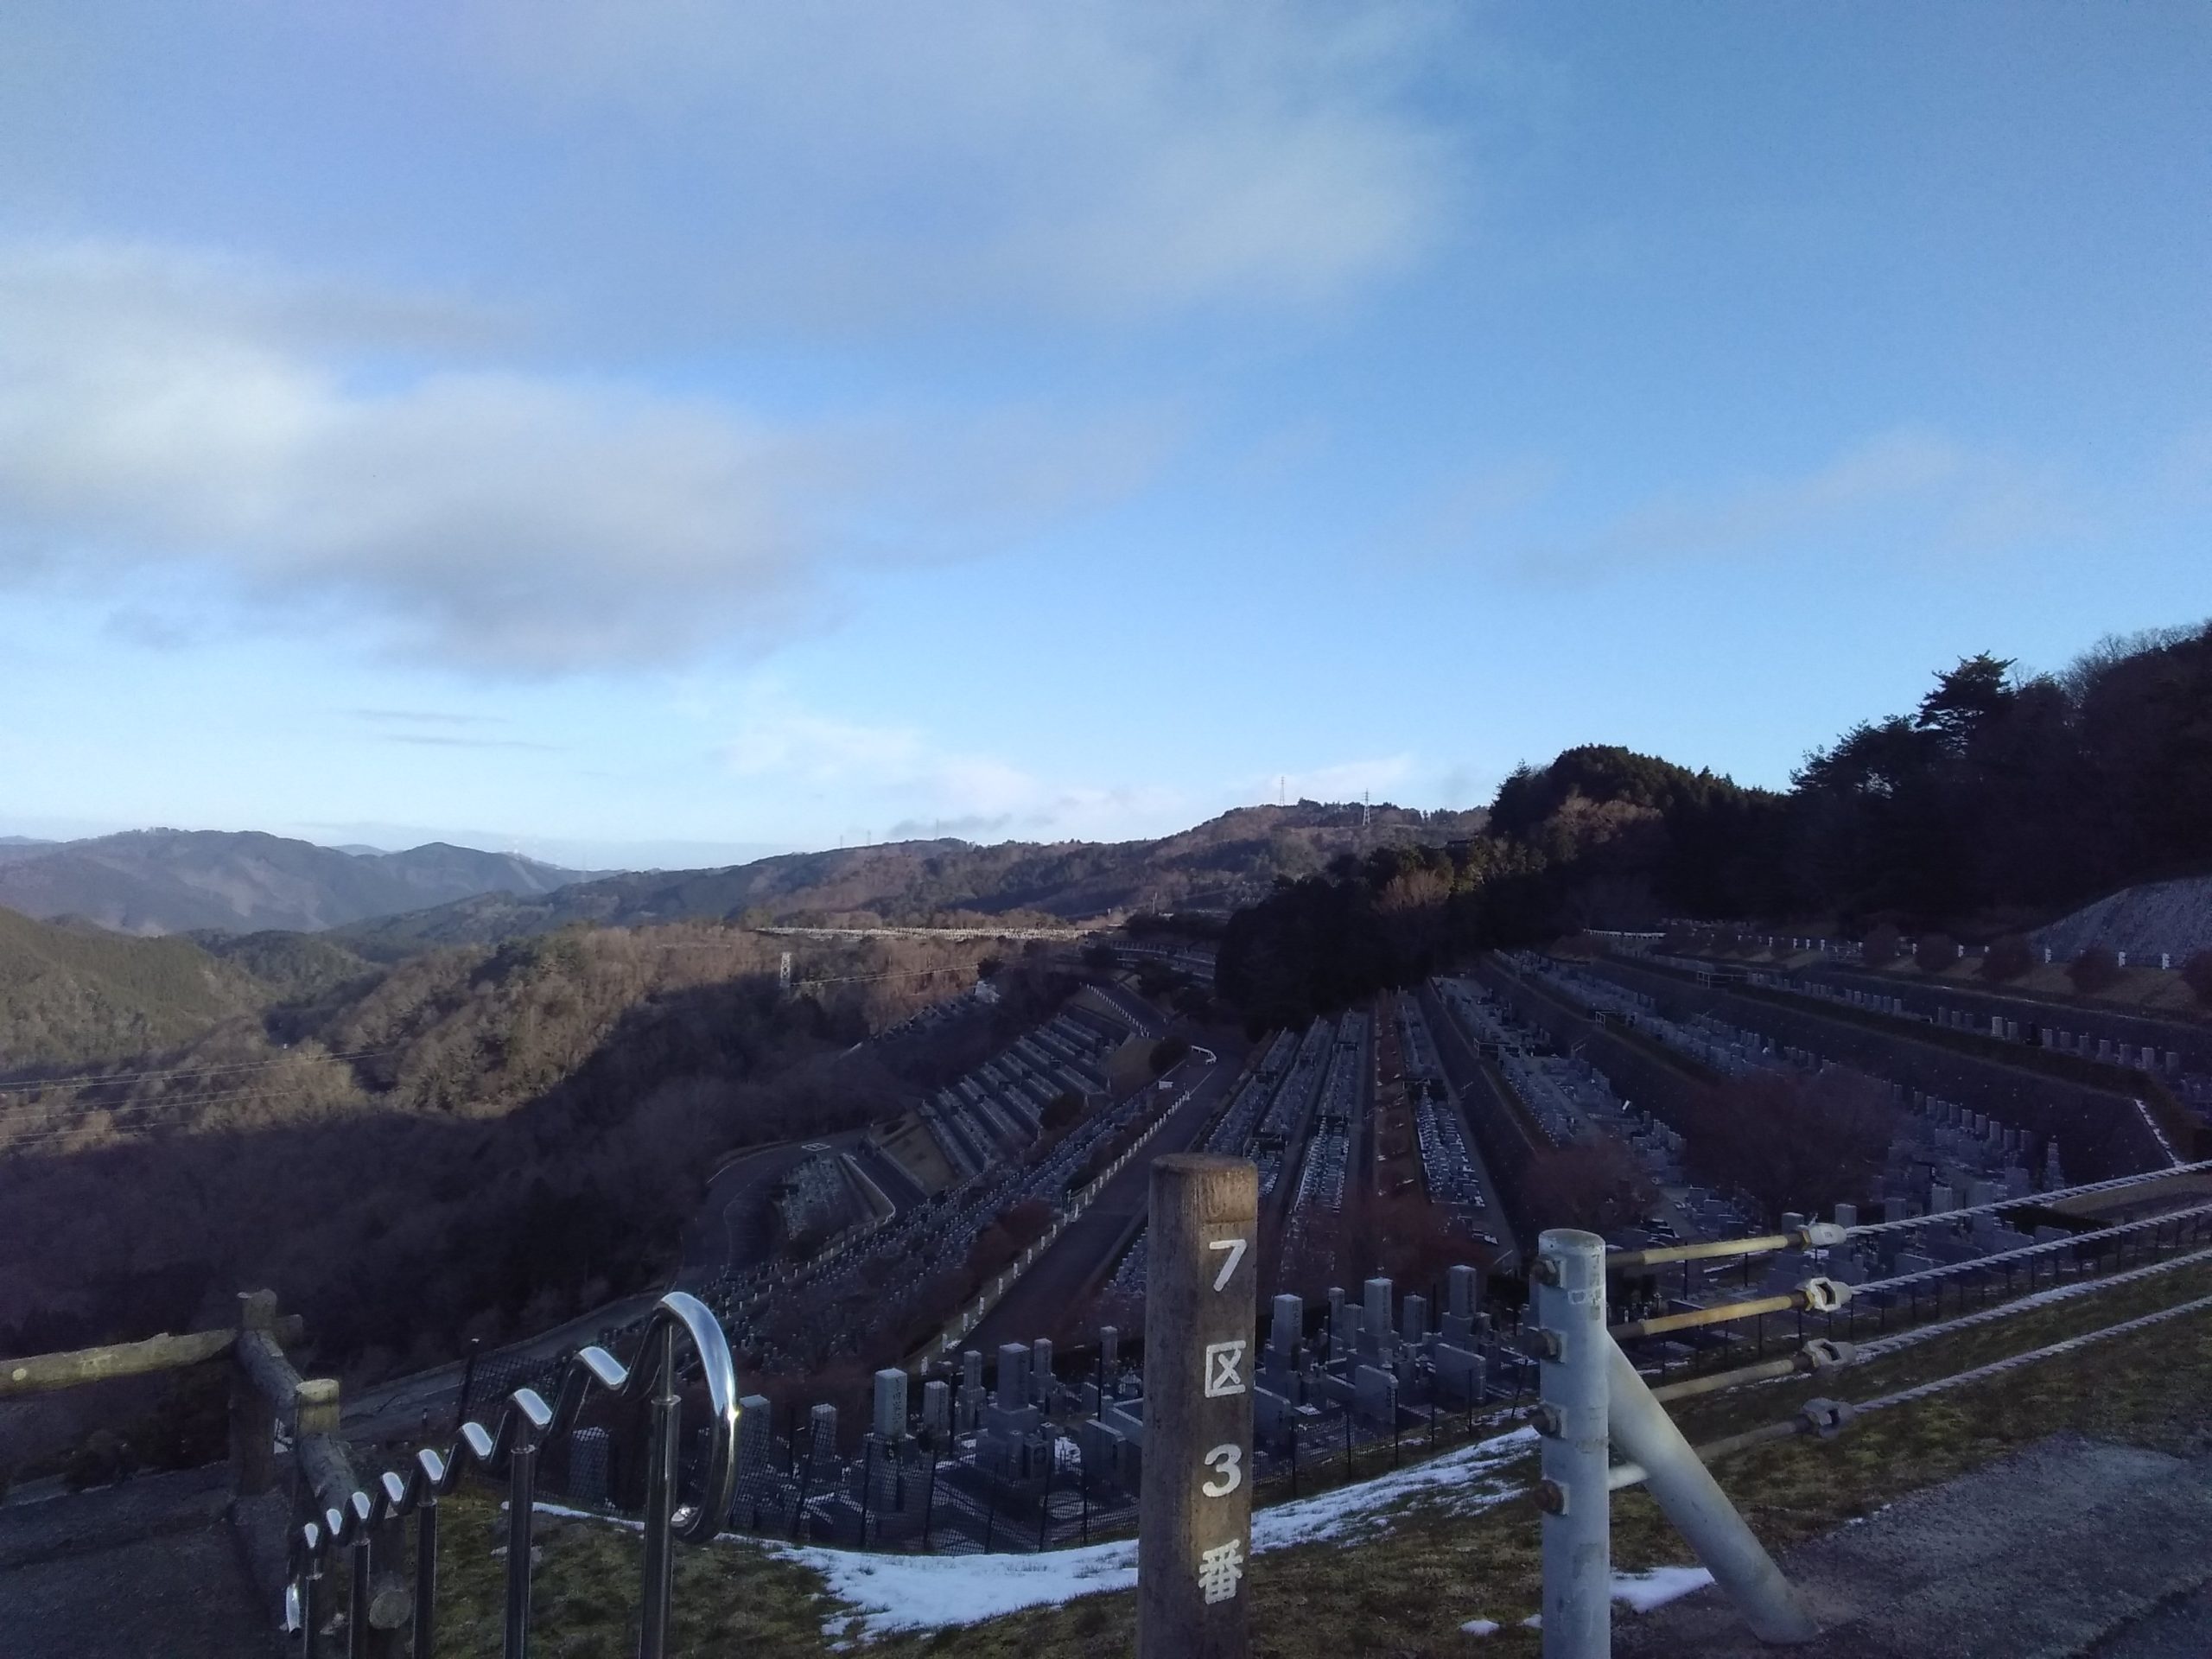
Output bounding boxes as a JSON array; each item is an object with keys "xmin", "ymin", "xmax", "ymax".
[{"xmin": 1137, "ymin": 1153, "xmax": 1259, "ymax": 1659}]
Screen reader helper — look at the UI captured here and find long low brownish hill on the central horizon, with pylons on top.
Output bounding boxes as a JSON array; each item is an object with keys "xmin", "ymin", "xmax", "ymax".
[{"xmin": 347, "ymin": 801, "xmax": 1482, "ymax": 953}]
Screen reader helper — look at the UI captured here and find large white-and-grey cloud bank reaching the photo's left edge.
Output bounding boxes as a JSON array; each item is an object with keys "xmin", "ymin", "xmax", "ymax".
[{"xmin": 0, "ymin": 244, "xmax": 1159, "ymax": 672}]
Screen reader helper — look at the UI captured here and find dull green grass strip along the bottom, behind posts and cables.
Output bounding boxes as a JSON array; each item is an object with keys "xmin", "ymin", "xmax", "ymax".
[{"xmin": 402, "ymin": 1268, "xmax": 2212, "ymax": 1659}]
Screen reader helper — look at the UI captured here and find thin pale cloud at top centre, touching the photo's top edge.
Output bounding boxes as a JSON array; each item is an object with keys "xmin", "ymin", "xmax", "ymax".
[{"xmin": 474, "ymin": 0, "xmax": 1476, "ymax": 325}]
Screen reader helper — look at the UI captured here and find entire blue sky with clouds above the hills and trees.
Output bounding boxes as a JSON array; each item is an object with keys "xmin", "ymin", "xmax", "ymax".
[{"xmin": 0, "ymin": 0, "xmax": 2212, "ymax": 868}]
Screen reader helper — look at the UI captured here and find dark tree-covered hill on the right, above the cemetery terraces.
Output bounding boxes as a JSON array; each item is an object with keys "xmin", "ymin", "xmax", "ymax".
[{"xmin": 1219, "ymin": 626, "xmax": 2212, "ymax": 1022}]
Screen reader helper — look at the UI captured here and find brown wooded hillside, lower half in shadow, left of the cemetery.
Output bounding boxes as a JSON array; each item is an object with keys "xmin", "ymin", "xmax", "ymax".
[{"xmin": 0, "ymin": 925, "xmax": 1048, "ymax": 1371}]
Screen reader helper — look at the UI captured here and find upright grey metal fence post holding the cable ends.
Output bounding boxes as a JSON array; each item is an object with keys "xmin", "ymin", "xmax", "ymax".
[{"xmin": 1533, "ymin": 1228, "xmax": 1615, "ymax": 1659}]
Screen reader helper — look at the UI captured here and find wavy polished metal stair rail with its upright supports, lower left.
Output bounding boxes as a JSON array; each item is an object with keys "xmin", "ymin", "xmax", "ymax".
[{"xmin": 288, "ymin": 1289, "xmax": 739, "ymax": 1659}]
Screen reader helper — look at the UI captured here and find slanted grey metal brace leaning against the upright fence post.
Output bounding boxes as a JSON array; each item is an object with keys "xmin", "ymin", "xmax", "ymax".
[{"xmin": 1601, "ymin": 1336, "xmax": 1821, "ymax": 1643}]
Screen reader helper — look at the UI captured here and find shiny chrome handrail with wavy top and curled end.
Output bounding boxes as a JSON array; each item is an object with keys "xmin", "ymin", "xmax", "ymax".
[{"xmin": 294, "ymin": 1289, "xmax": 739, "ymax": 1655}]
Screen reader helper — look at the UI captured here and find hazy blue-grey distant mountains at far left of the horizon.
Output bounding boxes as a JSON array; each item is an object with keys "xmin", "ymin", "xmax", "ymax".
[{"xmin": 0, "ymin": 830, "xmax": 593, "ymax": 933}]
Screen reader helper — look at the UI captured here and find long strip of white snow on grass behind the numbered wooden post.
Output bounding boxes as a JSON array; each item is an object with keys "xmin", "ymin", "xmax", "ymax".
[{"xmin": 763, "ymin": 1429, "xmax": 1535, "ymax": 1637}]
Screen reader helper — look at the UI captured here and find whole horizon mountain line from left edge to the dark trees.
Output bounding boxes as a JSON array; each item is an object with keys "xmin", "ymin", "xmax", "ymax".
[{"xmin": 0, "ymin": 801, "xmax": 1484, "ymax": 960}]
